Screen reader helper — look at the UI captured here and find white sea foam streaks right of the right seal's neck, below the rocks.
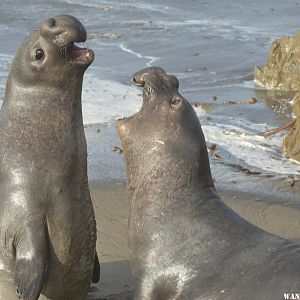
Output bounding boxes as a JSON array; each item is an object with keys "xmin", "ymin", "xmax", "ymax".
[{"xmin": 196, "ymin": 109, "xmax": 300, "ymax": 175}]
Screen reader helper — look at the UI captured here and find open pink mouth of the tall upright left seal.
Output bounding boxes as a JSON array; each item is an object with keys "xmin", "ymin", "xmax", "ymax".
[{"xmin": 59, "ymin": 42, "xmax": 94, "ymax": 64}]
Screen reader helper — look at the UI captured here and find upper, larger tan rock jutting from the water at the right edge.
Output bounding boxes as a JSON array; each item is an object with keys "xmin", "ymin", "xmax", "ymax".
[{"xmin": 254, "ymin": 31, "xmax": 300, "ymax": 91}]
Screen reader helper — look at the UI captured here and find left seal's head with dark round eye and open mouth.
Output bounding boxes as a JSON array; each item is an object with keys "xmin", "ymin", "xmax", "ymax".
[{"xmin": 11, "ymin": 15, "xmax": 94, "ymax": 86}]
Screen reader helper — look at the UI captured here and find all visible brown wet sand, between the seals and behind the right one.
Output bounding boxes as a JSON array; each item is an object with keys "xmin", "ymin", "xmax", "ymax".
[{"xmin": 88, "ymin": 182, "xmax": 300, "ymax": 300}]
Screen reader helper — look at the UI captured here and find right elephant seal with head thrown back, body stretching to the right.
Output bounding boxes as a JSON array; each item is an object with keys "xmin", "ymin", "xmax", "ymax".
[{"xmin": 116, "ymin": 67, "xmax": 300, "ymax": 300}]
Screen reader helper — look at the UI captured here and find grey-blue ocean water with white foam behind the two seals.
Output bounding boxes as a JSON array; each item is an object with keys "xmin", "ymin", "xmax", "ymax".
[{"xmin": 0, "ymin": 0, "xmax": 300, "ymax": 185}]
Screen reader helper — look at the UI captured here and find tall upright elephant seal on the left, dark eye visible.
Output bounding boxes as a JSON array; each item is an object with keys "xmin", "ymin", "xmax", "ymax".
[{"xmin": 0, "ymin": 15, "xmax": 99, "ymax": 300}]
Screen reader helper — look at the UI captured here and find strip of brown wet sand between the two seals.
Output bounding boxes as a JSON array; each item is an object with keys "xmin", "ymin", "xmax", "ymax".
[{"xmin": 88, "ymin": 183, "xmax": 133, "ymax": 300}]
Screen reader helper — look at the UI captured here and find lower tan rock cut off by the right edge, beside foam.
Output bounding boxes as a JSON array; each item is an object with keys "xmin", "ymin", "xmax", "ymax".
[{"xmin": 282, "ymin": 92, "xmax": 300, "ymax": 162}]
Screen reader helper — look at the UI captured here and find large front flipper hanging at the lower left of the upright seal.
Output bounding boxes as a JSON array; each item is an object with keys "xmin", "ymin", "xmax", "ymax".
[{"xmin": 14, "ymin": 218, "xmax": 49, "ymax": 300}]
